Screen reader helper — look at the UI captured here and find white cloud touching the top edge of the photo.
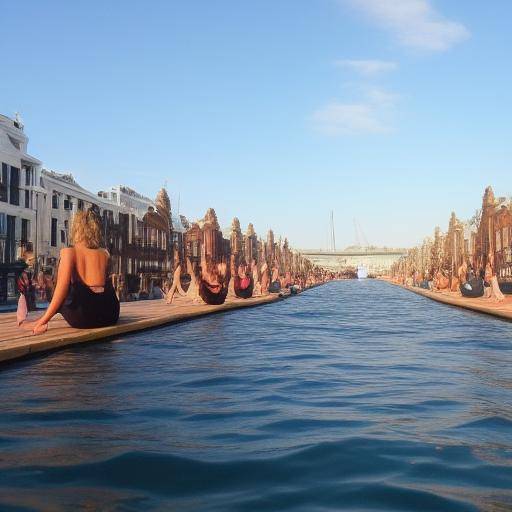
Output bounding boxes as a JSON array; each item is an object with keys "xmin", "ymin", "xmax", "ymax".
[{"xmin": 342, "ymin": 0, "xmax": 470, "ymax": 51}]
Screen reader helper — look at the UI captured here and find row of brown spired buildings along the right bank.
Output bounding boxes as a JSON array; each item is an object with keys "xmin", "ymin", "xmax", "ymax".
[{"xmin": 392, "ymin": 187, "xmax": 512, "ymax": 292}]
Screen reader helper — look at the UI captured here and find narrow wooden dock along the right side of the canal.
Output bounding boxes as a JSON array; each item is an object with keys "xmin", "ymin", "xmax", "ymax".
[{"xmin": 385, "ymin": 279, "xmax": 512, "ymax": 322}]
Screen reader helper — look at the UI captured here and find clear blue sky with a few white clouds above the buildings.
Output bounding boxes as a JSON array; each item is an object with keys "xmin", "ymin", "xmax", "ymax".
[{"xmin": 0, "ymin": 0, "xmax": 512, "ymax": 248}]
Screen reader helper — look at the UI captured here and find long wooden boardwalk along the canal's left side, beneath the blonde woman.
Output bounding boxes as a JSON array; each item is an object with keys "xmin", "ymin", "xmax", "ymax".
[{"xmin": 0, "ymin": 287, "xmax": 324, "ymax": 366}]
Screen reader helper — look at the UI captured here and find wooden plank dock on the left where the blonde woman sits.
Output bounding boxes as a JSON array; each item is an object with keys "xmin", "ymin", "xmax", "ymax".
[{"xmin": 0, "ymin": 294, "xmax": 286, "ymax": 363}]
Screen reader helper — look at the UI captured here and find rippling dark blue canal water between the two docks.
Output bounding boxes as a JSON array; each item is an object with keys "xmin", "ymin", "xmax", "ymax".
[{"xmin": 0, "ymin": 280, "xmax": 512, "ymax": 512}]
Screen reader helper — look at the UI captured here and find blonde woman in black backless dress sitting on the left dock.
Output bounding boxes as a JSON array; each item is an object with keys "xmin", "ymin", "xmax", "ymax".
[{"xmin": 21, "ymin": 210, "xmax": 119, "ymax": 334}]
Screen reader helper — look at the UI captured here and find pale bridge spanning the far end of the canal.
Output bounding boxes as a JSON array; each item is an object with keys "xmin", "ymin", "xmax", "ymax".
[{"xmin": 300, "ymin": 247, "xmax": 407, "ymax": 274}]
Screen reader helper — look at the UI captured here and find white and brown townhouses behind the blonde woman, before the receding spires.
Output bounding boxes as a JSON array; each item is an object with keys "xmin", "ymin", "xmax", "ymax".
[{"xmin": 0, "ymin": 115, "xmax": 185, "ymax": 303}]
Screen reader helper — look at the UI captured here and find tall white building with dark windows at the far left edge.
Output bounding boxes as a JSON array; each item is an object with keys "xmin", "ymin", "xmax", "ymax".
[{"xmin": 0, "ymin": 114, "xmax": 43, "ymax": 302}]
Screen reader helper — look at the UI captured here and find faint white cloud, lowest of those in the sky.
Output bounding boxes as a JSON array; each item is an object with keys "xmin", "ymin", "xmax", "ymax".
[{"xmin": 312, "ymin": 88, "xmax": 398, "ymax": 136}]
